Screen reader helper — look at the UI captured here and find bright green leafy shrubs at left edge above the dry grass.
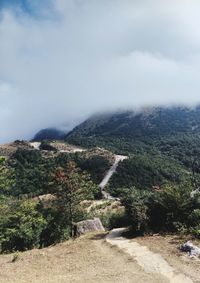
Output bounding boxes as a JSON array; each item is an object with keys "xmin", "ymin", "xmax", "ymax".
[{"xmin": 0, "ymin": 200, "xmax": 47, "ymax": 252}]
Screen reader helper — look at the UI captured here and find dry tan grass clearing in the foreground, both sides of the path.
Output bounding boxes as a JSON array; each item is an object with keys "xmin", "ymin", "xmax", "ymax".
[{"xmin": 0, "ymin": 233, "xmax": 200, "ymax": 283}]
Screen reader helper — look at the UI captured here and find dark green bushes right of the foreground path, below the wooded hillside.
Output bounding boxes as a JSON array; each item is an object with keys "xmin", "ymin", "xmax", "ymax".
[{"xmin": 121, "ymin": 184, "xmax": 200, "ymax": 234}]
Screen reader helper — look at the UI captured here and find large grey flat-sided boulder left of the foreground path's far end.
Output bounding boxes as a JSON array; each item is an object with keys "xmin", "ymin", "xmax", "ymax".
[{"xmin": 75, "ymin": 218, "xmax": 105, "ymax": 235}]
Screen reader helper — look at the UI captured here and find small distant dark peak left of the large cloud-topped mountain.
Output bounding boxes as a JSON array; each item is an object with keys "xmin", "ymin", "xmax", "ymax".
[{"xmin": 32, "ymin": 128, "xmax": 66, "ymax": 142}]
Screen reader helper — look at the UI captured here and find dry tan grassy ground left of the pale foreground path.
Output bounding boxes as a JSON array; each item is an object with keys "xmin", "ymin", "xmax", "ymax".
[{"xmin": 0, "ymin": 235, "xmax": 168, "ymax": 283}]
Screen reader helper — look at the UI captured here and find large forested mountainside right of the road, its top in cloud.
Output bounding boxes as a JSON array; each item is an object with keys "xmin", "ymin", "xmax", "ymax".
[{"xmin": 66, "ymin": 107, "xmax": 200, "ymax": 193}]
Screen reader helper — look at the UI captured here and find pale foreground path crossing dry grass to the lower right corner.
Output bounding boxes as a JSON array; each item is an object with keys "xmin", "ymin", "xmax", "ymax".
[{"xmin": 106, "ymin": 228, "xmax": 193, "ymax": 283}]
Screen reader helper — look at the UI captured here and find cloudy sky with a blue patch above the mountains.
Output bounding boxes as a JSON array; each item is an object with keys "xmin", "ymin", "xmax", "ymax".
[{"xmin": 0, "ymin": 0, "xmax": 200, "ymax": 143}]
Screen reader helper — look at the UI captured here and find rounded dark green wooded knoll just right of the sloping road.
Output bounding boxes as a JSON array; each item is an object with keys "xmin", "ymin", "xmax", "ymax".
[{"xmin": 110, "ymin": 154, "xmax": 189, "ymax": 195}]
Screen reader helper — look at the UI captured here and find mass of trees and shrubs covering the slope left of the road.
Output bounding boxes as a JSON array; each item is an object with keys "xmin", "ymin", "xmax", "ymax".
[{"xmin": 0, "ymin": 149, "xmax": 102, "ymax": 252}]
